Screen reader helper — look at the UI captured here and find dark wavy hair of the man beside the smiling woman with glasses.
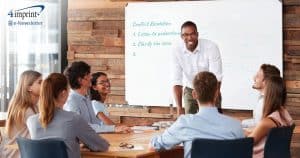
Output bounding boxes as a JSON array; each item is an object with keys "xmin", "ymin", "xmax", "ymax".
[{"xmin": 64, "ymin": 61, "xmax": 91, "ymax": 89}]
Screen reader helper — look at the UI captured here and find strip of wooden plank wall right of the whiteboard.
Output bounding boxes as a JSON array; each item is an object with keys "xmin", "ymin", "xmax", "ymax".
[{"xmin": 283, "ymin": 0, "xmax": 300, "ymax": 158}]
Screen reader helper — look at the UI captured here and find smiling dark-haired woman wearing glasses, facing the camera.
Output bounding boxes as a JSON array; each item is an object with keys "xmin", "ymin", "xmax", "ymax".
[{"xmin": 90, "ymin": 72, "xmax": 114, "ymax": 125}]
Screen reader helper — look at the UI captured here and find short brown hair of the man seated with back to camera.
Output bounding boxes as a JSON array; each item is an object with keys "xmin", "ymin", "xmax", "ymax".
[{"xmin": 193, "ymin": 71, "xmax": 218, "ymax": 103}]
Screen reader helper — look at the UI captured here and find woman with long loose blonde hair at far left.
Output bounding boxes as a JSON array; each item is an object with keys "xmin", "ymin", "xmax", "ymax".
[{"xmin": 0, "ymin": 70, "xmax": 42, "ymax": 158}]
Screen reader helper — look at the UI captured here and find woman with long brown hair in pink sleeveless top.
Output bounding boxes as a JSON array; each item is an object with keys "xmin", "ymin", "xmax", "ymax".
[{"xmin": 248, "ymin": 76, "xmax": 293, "ymax": 158}]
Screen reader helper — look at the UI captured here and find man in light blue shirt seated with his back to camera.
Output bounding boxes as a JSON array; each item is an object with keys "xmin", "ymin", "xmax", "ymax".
[{"xmin": 150, "ymin": 71, "xmax": 244, "ymax": 158}]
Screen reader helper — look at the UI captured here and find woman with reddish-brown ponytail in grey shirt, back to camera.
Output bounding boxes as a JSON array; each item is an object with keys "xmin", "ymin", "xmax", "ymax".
[{"xmin": 27, "ymin": 73, "xmax": 109, "ymax": 158}]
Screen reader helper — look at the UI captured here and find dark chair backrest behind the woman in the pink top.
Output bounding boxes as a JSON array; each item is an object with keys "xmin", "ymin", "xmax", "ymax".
[{"xmin": 264, "ymin": 124, "xmax": 295, "ymax": 158}]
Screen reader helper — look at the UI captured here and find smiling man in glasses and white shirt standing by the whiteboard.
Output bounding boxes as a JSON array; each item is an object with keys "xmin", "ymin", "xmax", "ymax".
[{"xmin": 172, "ymin": 21, "xmax": 222, "ymax": 115}]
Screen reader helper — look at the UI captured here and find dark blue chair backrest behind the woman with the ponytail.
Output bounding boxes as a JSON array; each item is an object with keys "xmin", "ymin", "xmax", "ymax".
[{"xmin": 17, "ymin": 138, "xmax": 68, "ymax": 158}]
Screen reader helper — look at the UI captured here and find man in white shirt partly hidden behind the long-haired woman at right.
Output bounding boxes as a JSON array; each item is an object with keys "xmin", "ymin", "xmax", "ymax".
[{"xmin": 242, "ymin": 64, "xmax": 280, "ymax": 128}]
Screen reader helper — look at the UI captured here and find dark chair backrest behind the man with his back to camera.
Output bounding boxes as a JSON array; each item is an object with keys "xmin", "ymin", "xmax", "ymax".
[{"xmin": 191, "ymin": 137, "xmax": 253, "ymax": 158}]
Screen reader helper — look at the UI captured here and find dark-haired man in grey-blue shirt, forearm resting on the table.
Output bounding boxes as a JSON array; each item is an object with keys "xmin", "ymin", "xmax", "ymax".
[{"xmin": 64, "ymin": 61, "xmax": 130, "ymax": 133}]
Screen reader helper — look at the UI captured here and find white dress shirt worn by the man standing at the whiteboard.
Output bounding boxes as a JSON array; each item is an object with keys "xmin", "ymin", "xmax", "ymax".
[{"xmin": 172, "ymin": 39, "xmax": 222, "ymax": 88}]
